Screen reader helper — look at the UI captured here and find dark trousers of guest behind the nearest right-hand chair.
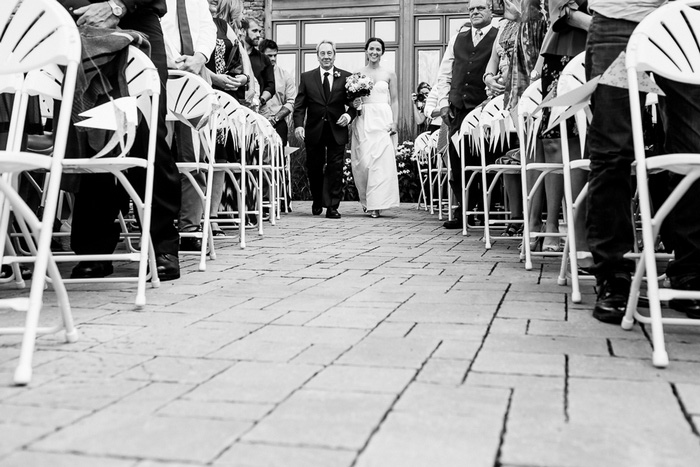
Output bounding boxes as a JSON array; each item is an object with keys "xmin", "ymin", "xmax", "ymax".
[{"xmin": 586, "ymin": 14, "xmax": 700, "ymax": 279}]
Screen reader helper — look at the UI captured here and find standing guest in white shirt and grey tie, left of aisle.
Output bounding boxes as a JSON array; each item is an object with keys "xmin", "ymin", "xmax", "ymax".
[{"xmin": 161, "ymin": 0, "xmax": 216, "ymax": 251}]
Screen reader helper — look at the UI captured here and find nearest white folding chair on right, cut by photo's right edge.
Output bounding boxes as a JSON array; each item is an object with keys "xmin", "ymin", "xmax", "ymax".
[{"xmin": 622, "ymin": 0, "xmax": 700, "ymax": 367}]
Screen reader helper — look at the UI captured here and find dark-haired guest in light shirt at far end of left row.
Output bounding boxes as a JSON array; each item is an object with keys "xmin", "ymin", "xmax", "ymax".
[{"xmin": 258, "ymin": 39, "xmax": 297, "ymax": 146}]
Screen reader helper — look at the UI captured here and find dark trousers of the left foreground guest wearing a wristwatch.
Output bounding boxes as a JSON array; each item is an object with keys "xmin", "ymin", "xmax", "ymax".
[{"xmin": 71, "ymin": 10, "xmax": 180, "ymax": 254}]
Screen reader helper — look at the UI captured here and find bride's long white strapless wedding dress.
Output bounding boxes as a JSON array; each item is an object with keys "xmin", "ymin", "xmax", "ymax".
[{"xmin": 350, "ymin": 81, "xmax": 399, "ymax": 211}]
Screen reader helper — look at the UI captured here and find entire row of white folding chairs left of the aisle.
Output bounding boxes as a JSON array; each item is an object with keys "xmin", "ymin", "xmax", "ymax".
[{"xmin": 0, "ymin": 0, "xmax": 286, "ymax": 384}]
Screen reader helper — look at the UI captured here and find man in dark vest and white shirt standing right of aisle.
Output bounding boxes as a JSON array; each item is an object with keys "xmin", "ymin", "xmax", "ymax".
[{"xmin": 436, "ymin": 0, "xmax": 498, "ymax": 229}]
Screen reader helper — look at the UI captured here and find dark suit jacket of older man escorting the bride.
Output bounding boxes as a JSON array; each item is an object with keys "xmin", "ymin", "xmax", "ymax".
[{"xmin": 294, "ymin": 68, "xmax": 357, "ymax": 144}]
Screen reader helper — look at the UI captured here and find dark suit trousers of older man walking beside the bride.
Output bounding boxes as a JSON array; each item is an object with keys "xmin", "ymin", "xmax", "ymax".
[{"xmin": 306, "ymin": 123, "xmax": 345, "ymax": 209}]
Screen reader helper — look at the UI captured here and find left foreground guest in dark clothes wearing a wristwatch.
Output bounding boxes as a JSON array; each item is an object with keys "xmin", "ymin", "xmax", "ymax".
[{"xmin": 71, "ymin": 0, "xmax": 180, "ymax": 281}]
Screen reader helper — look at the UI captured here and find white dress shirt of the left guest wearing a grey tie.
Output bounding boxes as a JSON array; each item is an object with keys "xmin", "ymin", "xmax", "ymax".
[{"xmin": 160, "ymin": 0, "xmax": 216, "ymax": 61}]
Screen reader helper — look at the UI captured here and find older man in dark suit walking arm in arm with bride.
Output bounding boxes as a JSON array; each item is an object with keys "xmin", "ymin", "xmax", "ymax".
[{"xmin": 294, "ymin": 40, "xmax": 356, "ymax": 219}]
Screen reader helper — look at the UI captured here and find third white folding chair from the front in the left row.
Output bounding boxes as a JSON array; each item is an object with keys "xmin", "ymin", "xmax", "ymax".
[{"xmin": 166, "ymin": 70, "xmax": 219, "ymax": 271}]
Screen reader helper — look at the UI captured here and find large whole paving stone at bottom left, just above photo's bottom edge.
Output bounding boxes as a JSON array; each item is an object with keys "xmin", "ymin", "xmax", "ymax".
[{"xmin": 30, "ymin": 411, "xmax": 250, "ymax": 462}]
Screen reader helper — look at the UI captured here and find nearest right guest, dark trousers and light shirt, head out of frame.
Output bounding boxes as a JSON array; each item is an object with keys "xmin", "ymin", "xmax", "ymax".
[{"xmin": 586, "ymin": 0, "xmax": 700, "ymax": 324}]
